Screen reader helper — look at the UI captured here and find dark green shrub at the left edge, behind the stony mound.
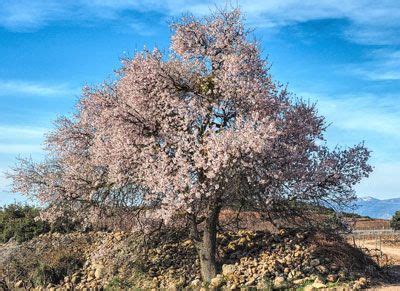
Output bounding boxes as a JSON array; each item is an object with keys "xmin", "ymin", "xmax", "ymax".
[{"xmin": 0, "ymin": 203, "xmax": 50, "ymax": 243}]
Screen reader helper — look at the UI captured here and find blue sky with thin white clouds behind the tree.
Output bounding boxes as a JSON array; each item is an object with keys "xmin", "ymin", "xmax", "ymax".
[{"xmin": 0, "ymin": 0, "xmax": 400, "ymax": 204}]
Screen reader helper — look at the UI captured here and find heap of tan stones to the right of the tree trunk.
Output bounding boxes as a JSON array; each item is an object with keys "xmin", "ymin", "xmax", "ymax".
[{"xmin": 209, "ymin": 231, "xmax": 365, "ymax": 289}]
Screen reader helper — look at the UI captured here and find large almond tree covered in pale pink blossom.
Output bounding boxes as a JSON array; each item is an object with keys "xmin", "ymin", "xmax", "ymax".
[{"xmin": 11, "ymin": 10, "xmax": 371, "ymax": 281}]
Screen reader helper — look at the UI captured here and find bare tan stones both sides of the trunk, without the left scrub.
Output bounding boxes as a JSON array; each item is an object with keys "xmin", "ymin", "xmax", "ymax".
[{"xmin": 0, "ymin": 231, "xmax": 376, "ymax": 290}]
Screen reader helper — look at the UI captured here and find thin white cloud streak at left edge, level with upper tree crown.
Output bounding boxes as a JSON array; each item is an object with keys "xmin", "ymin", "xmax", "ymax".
[{"xmin": 0, "ymin": 79, "xmax": 77, "ymax": 96}]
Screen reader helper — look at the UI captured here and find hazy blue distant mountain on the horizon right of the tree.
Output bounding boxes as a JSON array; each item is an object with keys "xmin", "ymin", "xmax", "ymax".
[{"xmin": 354, "ymin": 197, "xmax": 400, "ymax": 219}]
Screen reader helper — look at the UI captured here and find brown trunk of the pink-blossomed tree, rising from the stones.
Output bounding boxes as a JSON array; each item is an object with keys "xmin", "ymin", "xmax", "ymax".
[{"xmin": 198, "ymin": 208, "xmax": 219, "ymax": 282}]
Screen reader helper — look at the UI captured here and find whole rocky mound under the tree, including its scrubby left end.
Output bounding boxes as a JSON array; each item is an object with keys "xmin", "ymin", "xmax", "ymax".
[{"xmin": 0, "ymin": 230, "xmax": 379, "ymax": 289}]
